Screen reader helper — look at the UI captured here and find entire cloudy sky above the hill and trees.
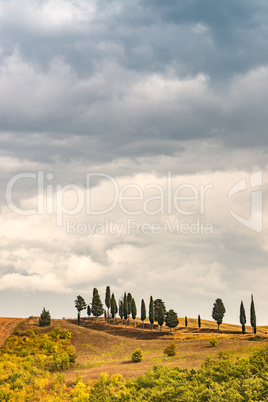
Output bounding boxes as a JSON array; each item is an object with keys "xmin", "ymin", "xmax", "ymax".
[{"xmin": 0, "ymin": 0, "xmax": 268, "ymax": 325}]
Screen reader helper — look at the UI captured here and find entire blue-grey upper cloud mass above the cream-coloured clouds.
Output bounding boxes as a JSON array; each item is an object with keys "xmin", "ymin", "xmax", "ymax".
[{"xmin": 0, "ymin": 0, "xmax": 268, "ymax": 161}]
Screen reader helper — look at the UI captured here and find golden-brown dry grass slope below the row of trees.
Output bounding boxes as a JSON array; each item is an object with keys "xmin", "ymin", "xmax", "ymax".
[{"xmin": 5, "ymin": 318, "xmax": 268, "ymax": 383}]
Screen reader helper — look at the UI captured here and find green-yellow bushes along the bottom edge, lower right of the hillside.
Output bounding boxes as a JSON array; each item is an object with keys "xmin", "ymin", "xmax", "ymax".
[{"xmin": 84, "ymin": 346, "xmax": 268, "ymax": 402}]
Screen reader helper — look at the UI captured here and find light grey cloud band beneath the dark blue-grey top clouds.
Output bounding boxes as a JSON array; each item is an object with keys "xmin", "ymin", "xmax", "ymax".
[{"xmin": 0, "ymin": 55, "xmax": 268, "ymax": 160}]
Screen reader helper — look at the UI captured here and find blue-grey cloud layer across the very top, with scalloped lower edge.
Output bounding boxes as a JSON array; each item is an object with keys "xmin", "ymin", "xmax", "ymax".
[{"xmin": 1, "ymin": 0, "xmax": 268, "ymax": 79}]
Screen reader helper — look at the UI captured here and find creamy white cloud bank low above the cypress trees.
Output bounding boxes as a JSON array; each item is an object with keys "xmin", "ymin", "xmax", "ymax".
[{"xmin": 0, "ymin": 162, "xmax": 268, "ymax": 322}]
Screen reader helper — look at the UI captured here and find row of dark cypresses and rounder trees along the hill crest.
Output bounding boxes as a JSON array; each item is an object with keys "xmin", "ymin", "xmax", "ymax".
[{"xmin": 75, "ymin": 286, "xmax": 257, "ymax": 334}]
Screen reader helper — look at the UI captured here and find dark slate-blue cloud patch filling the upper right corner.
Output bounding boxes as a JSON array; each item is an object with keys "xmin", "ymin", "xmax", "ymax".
[{"xmin": 143, "ymin": 0, "xmax": 268, "ymax": 79}]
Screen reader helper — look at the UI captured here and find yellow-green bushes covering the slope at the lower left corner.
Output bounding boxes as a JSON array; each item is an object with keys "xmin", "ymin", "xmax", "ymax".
[{"xmin": 0, "ymin": 327, "xmax": 76, "ymax": 401}]
